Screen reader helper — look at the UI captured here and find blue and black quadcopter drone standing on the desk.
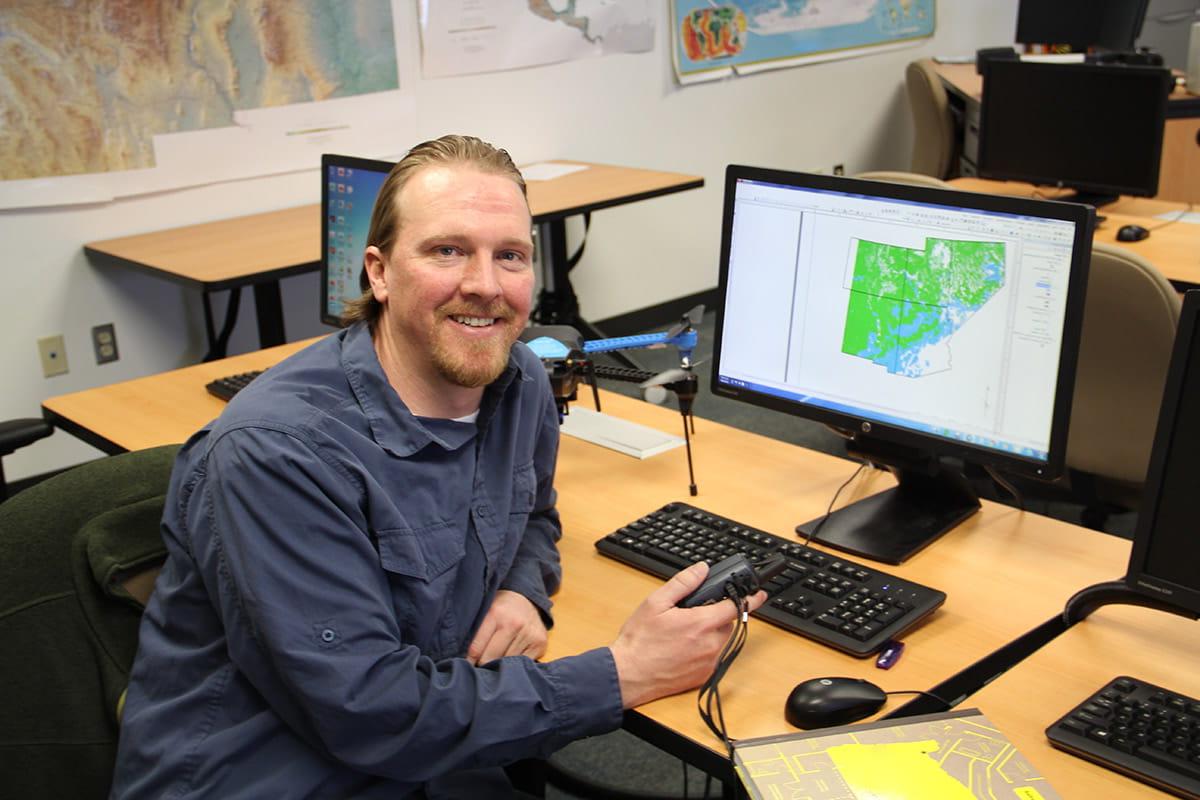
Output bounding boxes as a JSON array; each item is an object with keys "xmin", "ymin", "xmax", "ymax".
[{"xmin": 521, "ymin": 306, "xmax": 704, "ymax": 497}]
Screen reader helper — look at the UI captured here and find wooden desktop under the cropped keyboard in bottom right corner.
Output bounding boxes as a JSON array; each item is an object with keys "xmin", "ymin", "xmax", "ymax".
[{"xmin": 964, "ymin": 606, "xmax": 1200, "ymax": 800}]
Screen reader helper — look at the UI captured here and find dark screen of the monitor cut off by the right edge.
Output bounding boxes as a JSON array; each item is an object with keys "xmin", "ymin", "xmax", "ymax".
[{"xmin": 1127, "ymin": 291, "xmax": 1200, "ymax": 614}]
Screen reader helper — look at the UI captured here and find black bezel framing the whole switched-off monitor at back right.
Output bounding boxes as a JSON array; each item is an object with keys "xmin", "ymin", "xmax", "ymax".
[{"xmin": 976, "ymin": 60, "xmax": 1172, "ymax": 197}]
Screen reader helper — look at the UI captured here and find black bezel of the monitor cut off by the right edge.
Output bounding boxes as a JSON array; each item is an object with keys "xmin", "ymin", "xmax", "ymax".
[{"xmin": 1126, "ymin": 290, "xmax": 1200, "ymax": 614}]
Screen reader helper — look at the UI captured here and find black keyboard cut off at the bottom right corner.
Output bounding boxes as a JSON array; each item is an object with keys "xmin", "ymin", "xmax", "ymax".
[{"xmin": 1046, "ymin": 675, "xmax": 1200, "ymax": 798}]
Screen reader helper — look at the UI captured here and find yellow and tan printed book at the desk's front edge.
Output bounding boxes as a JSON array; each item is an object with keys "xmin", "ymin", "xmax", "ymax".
[{"xmin": 733, "ymin": 709, "xmax": 1061, "ymax": 800}]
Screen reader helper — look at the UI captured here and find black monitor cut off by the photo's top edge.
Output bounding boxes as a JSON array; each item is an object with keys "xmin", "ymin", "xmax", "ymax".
[{"xmin": 1016, "ymin": 0, "xmax": 1150, "ymax": 53}]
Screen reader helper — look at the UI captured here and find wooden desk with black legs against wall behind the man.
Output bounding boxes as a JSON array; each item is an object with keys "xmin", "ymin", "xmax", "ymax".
[{"xmin": 83, "ymin": 162, "xmax": 704, "ymax": 361}]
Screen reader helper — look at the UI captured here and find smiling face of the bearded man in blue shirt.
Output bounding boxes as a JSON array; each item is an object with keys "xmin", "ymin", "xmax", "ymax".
[{"xmin": 366, "ymin": 166, "xmax": 534, "ymax": 387}]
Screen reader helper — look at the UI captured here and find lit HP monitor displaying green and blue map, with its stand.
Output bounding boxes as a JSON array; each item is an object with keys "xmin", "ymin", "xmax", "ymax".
[{"xmin": 712, "ymin": 166, "xmax": 1094, "ymax": 564}]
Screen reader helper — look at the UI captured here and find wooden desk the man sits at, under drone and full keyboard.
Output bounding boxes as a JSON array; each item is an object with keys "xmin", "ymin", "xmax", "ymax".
[{"xmin": 43, "ymin": 341, "xmax": 1129, "ymax": 780}]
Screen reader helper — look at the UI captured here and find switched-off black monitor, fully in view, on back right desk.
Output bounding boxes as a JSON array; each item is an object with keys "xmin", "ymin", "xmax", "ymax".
[{"xmin": 977, "ymin": 61, "xmax": 1172, "ymax": 205}]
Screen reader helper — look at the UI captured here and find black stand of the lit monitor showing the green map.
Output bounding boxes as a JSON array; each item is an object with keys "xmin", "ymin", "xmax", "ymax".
[{"xmin": 796, "ymin": 458, "xmax": 979, "ymax": 564}]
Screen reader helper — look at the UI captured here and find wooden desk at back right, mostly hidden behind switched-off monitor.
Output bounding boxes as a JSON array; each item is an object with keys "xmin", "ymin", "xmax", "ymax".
[{"xmin": 934, "ymin": 62, "xmax": 1200, "ymax": 203}]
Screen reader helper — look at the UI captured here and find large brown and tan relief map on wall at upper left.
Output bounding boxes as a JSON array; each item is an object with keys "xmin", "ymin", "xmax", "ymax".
[{"xmin": 0, "ymin": 0, "xmax": 404, "ymax": 207}]
